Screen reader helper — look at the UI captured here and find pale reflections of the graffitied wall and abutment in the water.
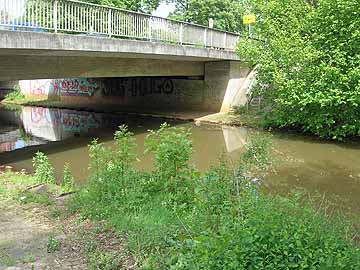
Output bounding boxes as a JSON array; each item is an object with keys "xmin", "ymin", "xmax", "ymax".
[{"xmin": 0, "ymin": 107, "xmax": 247, "ymax": 152}]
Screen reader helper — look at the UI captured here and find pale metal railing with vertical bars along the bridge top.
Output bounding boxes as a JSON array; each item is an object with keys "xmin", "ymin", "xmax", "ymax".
[{"xmin": 0, "ymin": 0, "xmax": 239, "ymax": 50}]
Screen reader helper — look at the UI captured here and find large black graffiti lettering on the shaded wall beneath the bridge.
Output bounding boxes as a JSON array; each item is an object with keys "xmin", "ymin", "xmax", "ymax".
[{"xmin": 102, "ymin": 78, "xmax": 174, "ymax": 97}]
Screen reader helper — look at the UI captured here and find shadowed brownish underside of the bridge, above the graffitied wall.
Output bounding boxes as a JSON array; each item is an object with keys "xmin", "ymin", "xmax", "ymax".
[{"xmin": 0, "ymin": 55, "xmax": 204, "ymax": 81}]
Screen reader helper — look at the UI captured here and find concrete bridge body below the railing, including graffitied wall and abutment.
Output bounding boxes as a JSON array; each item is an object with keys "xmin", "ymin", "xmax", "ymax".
[{"xmin": 0, "ymin": 31, "xmax": 250, "ymax": 112}]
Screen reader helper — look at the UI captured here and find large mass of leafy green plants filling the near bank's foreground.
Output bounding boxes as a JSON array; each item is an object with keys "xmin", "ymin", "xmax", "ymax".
[{"xmin": 71, "ymin": 124, "xmax": 360, "ymax": 270}]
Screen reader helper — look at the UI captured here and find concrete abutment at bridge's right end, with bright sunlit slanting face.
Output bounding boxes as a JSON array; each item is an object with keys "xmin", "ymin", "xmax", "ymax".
[{"xmin": 204, "ymin": 61, "xmax": 252, "ymax": 112}]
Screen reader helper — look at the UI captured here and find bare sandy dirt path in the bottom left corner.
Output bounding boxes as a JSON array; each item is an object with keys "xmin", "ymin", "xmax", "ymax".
[{"xmin": 0, "ymin": 201, "xmax": 87, "ymax": 270}]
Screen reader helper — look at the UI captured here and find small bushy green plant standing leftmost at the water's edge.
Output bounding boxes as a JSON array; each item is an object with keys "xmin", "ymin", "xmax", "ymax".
[{"xmin": 32, "ymin": 151, "xmax": 55, "ymax": 184}]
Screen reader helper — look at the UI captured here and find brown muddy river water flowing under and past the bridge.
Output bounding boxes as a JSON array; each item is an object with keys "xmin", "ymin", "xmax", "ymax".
[{"xmin": 0, "ymin": 107, "xmax": 360, "ymax": 216}]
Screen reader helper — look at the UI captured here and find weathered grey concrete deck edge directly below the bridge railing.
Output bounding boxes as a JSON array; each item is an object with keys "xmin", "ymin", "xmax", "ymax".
[{"xmin": 0, "ymin": 30, "xmax": 240, "ymax": 61}]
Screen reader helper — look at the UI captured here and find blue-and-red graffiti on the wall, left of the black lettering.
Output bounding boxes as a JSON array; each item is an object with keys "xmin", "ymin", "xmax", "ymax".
[{"xmin": 50, "ymin": 78, "xmax": 99, "ymax": 97}]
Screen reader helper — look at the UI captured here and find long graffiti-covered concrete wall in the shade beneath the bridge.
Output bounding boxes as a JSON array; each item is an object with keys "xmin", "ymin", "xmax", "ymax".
[{"xmin": 20, "ymin": 77, "xmax": 206, "ymax": 111}]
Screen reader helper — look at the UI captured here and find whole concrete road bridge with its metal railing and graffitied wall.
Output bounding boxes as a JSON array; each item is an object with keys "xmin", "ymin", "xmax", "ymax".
[{"xmin": 0, "ymin": 0, "xmax": 254, "ymax": 112}]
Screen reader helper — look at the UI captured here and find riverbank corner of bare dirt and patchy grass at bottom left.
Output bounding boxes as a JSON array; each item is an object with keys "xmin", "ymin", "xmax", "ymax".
[{"xmin": 0, "ymin": 171, "xmax": 136, "ymax": 270}]
